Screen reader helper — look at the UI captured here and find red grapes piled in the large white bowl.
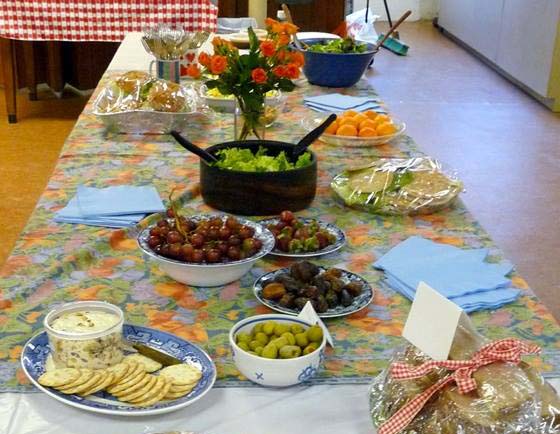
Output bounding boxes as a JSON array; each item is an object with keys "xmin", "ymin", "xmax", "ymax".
[{"xmin": 147, "ymin": 210, "xmax": 262, "ymax": 264}]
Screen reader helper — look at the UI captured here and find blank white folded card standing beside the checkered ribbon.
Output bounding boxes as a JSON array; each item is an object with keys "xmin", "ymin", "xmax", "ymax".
[{"xmin": 402, "ymin": 282, "xmax": 470, "ymax": 360}]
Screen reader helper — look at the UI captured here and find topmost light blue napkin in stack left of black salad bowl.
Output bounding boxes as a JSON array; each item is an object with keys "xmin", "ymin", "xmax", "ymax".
[{"xmin": 76, "ymin": 185, "xmax": 165, "ymax": 217}]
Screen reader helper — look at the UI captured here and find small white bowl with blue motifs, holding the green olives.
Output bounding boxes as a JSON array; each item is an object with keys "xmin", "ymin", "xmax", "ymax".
[{"xmin": 229, "ymin": 314, "xmax": 327, "ymax": 387}]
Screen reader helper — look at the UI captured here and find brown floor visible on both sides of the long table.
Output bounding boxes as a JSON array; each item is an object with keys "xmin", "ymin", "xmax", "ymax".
[{"xmin": 0, "ymin": 22, "xmax": 560, "ymax": 318}]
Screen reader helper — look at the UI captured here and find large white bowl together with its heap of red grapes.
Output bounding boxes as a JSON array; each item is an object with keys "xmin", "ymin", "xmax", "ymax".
[{"xmin": 138, "ymin": 210, "xmax": 275, "ymax": 286}]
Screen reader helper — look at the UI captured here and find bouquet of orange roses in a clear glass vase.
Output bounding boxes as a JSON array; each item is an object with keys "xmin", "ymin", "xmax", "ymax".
[{"xmin": 198, "ymin": 18, "xmax": 304, "ymax": 140}]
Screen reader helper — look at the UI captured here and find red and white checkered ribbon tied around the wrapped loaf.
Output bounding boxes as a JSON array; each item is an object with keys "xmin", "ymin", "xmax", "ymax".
[{"xmin": 378, "ymin": 339, "xmax": 541, "ymax": 434}]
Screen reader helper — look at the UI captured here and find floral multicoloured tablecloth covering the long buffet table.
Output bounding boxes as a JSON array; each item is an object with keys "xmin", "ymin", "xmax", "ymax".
[{"xmin": 0, "ymin": 73, "xmax": 560, "ymax": 392}]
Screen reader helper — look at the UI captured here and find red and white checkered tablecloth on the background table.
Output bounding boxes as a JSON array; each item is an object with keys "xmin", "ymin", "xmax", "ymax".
[{"xmin": 0, "ymin": 0, "xmax": 218, "ymax": 41}]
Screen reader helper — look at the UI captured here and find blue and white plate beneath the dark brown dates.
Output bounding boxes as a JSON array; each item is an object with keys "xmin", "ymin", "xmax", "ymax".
[{"xmin": 253, "ymin": 266, "xmax": 373, "ymax": 318}]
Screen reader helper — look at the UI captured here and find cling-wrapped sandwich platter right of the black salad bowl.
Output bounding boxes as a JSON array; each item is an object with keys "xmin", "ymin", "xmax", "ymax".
[{"xmin": 331, "ymin": 157, "xmax": 463, "ymax": 215}]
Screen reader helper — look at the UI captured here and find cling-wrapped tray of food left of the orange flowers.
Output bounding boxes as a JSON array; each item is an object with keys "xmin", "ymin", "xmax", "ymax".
[{"xmin": 93, "ymin": 71, "xmax": 210, "ymax": 133}]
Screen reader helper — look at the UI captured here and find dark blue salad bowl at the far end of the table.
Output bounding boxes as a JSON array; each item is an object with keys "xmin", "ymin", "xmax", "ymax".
[{"xmin": 301, "ymin": 38, "xmax": 376, "ymax": 87}]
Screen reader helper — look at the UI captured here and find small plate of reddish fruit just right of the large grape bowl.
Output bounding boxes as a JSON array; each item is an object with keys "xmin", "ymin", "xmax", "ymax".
[{"xmin": 259, "ymin": 210, "xmax": 346, "ymax": 258}]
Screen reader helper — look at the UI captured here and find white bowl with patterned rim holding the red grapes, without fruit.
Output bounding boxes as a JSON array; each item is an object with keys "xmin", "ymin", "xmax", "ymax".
[{"xmin": 138, "ymin": 215, "xmax": 275, "ymax": 286}]
